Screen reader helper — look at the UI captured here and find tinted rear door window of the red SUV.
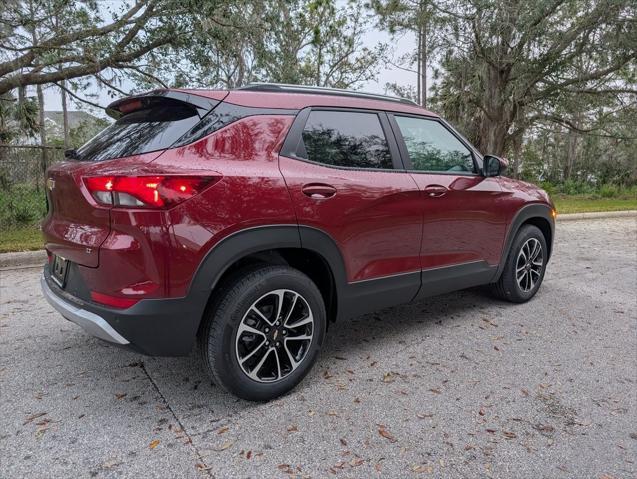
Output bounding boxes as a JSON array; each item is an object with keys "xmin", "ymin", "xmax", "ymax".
[{"xmin": 300, "ymin": 111, "xmax": 393, "ymax": 169}]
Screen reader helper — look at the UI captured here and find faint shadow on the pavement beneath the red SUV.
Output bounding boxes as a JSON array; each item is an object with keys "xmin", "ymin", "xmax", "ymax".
[{"xmin": 51, "ymin": 289, "xmax": 513, "ymax": 428}]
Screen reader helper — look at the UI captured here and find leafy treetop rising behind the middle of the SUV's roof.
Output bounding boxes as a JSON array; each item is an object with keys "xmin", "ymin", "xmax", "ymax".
[{"xmin": 155, "ymin": 0, "xmax": 386, "ymax": 88}]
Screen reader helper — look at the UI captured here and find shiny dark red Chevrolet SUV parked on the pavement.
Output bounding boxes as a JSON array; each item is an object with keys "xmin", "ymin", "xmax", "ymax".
[{"xmin": 42, "ymin": 84, "xmax": 555, "ymax": 400}]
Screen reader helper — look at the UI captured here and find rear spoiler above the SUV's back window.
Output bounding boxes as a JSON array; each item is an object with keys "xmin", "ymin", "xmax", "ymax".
[{"xmin": 106, "ymin": 90, "xmax": 219, "ymax": 120}]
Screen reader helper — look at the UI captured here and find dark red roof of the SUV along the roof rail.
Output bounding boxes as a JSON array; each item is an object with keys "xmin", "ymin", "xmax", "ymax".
[{"xmin": 179, "ymin": 84, "xmax": 438, "ymax": 117}]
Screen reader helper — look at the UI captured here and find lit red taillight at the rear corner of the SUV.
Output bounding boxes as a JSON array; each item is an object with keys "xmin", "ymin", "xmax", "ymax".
[{"xmin": 84, "ymin": 176, "xmax": 213, "ymax": 208}]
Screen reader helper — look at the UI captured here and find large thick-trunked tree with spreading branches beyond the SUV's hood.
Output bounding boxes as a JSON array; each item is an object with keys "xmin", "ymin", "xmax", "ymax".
[{"xmin": 435, "ymin": 0, "xmax": 637, "ymax": 155}]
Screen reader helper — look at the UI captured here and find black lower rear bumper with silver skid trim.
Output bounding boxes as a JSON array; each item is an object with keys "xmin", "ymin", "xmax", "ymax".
[{"xmin": 40, "ymin": 265, "xmax": 207, "ymax": 356}]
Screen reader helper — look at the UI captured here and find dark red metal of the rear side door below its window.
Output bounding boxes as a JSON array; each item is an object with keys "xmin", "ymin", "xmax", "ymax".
[{"xmin": 280, "ymin": 156, "xmax": 422, "ymax": 282}]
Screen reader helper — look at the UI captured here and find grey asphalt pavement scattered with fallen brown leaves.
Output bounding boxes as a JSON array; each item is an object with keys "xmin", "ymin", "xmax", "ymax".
[{"xmin": 0, "ymin": 218, "xmax": 637, "ymax": 479}]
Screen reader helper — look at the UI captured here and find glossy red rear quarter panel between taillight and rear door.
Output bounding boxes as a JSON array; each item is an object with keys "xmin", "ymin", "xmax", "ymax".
[{"xmin": 152, "ymin": 115, "xmax": 296, "ymax": 297}]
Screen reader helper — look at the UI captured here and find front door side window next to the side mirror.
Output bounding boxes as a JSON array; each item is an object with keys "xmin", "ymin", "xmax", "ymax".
[{"xmin": 394, "ymin": 115, "xmax": 475, "ymax": 173}]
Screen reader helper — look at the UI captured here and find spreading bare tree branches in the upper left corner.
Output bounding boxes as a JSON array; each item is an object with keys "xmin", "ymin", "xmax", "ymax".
[{"xmin": 0, "ymin": 0, "xmax": 195, "ymax": 94}]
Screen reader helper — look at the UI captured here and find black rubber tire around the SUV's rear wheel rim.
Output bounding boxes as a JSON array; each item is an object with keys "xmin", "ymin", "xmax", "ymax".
[{"xmin": 207, "ymin": 266, "xmax": 326, "ymax": 401}]
